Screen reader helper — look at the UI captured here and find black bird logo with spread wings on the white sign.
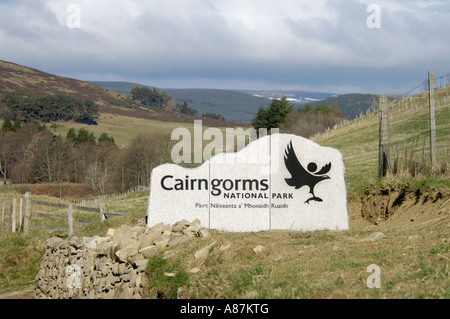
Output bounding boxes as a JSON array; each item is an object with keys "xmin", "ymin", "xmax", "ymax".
[{"xmin": 284, "ymin": 141, "xmax": 331, "ymax": 204}]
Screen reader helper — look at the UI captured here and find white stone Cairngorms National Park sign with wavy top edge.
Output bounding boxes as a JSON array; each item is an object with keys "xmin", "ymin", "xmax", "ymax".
[{"xmin": 147, "ymin": 134, "xmax": 349, "ymax": 232}]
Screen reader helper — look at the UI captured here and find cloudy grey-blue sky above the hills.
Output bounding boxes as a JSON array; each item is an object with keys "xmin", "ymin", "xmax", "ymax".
[{"xmin": 0, "ymin": 0, "xmax": 450, "ymax": 94}]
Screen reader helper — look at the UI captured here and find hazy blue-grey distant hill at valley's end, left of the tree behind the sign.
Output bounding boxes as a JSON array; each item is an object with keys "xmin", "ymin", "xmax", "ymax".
[{"xmin": 90, "ymin": 81, "xmax": 270, "ymax": 122}]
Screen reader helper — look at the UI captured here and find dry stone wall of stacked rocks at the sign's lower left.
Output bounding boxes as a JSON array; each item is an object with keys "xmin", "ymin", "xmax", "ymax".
[{"xmin": 35, "ymin": 220, "xmax": 210, "ymax": 299}]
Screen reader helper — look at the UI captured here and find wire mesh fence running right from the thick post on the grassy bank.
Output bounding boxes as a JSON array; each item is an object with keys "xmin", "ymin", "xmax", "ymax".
[{"xmin": 387, "ymin": 72, "xmax": 450, "ymax": 176}]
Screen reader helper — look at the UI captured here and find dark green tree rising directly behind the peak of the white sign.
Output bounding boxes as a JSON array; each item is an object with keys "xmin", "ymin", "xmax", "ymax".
[{"xmin": 252, "ymin": 97, "xmax": 293, "ymax": 130}]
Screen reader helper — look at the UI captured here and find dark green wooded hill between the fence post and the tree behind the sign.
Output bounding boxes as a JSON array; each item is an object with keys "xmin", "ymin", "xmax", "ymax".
[{"xmin": 308, "ymin": 93, "xmax": 378, "ymax": 119}]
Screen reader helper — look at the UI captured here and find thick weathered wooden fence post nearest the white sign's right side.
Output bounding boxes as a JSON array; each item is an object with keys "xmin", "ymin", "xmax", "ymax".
[{"xmin": 378, "ymin": 95, "xmax": 390, "ymax": 177}]
